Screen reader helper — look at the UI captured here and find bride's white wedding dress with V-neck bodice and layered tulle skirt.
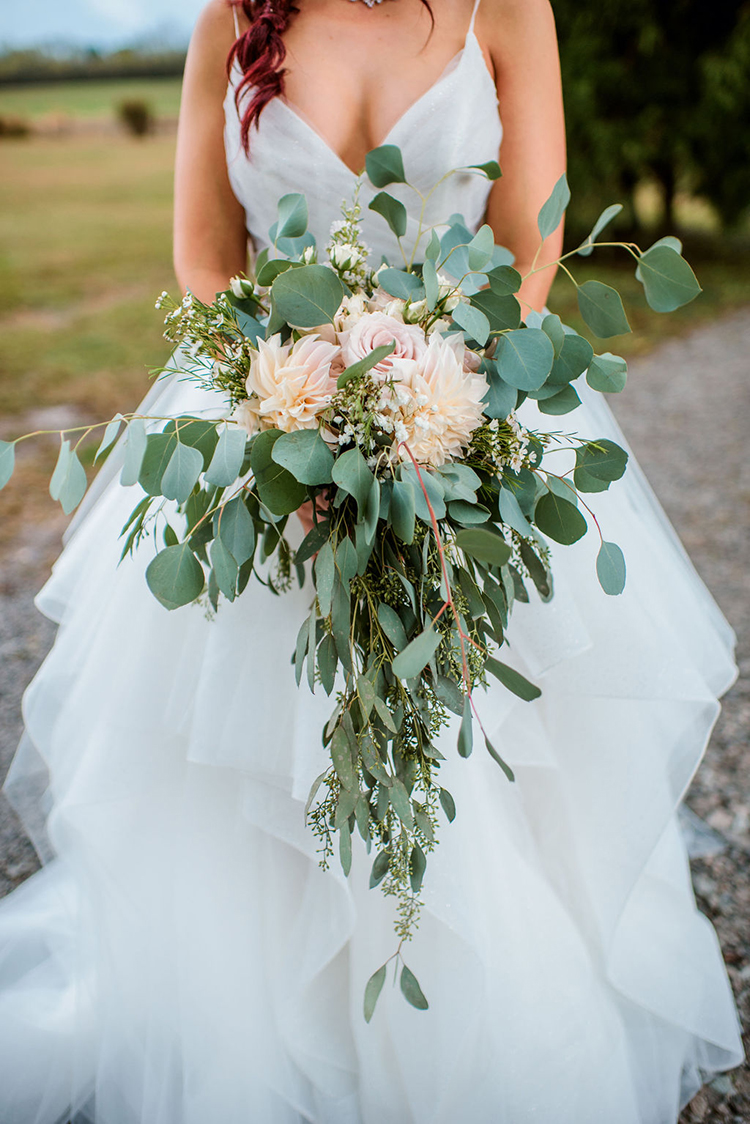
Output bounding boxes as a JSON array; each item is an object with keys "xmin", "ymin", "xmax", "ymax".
[{"xmin": 0, "ymin": 4, "xmax": 742, "ymax": 1124}]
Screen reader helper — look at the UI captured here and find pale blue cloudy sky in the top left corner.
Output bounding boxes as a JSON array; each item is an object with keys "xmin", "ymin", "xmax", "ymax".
[{"xmin": 0, "ymin": 0, "xmax": 205, "ymax": 46}]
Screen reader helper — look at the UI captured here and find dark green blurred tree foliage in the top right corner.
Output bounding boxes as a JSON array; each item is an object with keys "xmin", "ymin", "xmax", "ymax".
[{"xmin": 552, "ymin": 0, "xmax": 750, "ymax": 228}]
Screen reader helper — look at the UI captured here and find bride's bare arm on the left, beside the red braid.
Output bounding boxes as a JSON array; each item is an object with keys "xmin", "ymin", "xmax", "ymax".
[{"xmin": 174, "ymin": 0, "xmax": 247, "ymax": 302}]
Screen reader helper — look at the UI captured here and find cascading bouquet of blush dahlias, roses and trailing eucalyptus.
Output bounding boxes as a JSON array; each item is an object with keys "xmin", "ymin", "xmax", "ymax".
[{"xmin": 0, "ymin": 145, "xmax": 701, "ymax": 1021}]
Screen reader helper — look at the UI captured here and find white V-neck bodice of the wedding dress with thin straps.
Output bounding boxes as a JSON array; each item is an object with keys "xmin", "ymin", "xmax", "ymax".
[{"xmin": 225, "ymin": 0, "xmax": 503, "ymax": 263}]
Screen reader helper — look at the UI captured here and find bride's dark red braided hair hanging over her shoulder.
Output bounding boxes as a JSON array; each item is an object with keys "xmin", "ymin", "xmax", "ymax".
[{"xmin": 227, "ymin": 0, "xmax": 435, "ymax": 152}]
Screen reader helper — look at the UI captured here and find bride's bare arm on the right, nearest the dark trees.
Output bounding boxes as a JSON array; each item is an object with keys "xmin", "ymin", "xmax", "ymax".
[{"xmin": 477, "ymin": 0, "xmax": 566, "ymax": 315}]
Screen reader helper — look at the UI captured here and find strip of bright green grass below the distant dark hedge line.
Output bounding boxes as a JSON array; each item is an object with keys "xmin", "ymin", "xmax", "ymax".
[{"xmin": 0, "ymin": 78, "xmax": 181, "ymax": 120}]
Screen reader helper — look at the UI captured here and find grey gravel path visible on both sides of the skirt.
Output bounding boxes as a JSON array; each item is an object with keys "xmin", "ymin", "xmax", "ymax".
[{"xmin": 0, "ymin": 308, "xmax": 750, "ymax": 1124}]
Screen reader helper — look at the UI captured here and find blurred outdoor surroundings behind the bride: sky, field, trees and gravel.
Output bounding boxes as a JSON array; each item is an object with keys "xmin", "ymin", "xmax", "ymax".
[{"xmin": 0, "ymin": 0, "xmax": 750, "ymax": 1124}]
